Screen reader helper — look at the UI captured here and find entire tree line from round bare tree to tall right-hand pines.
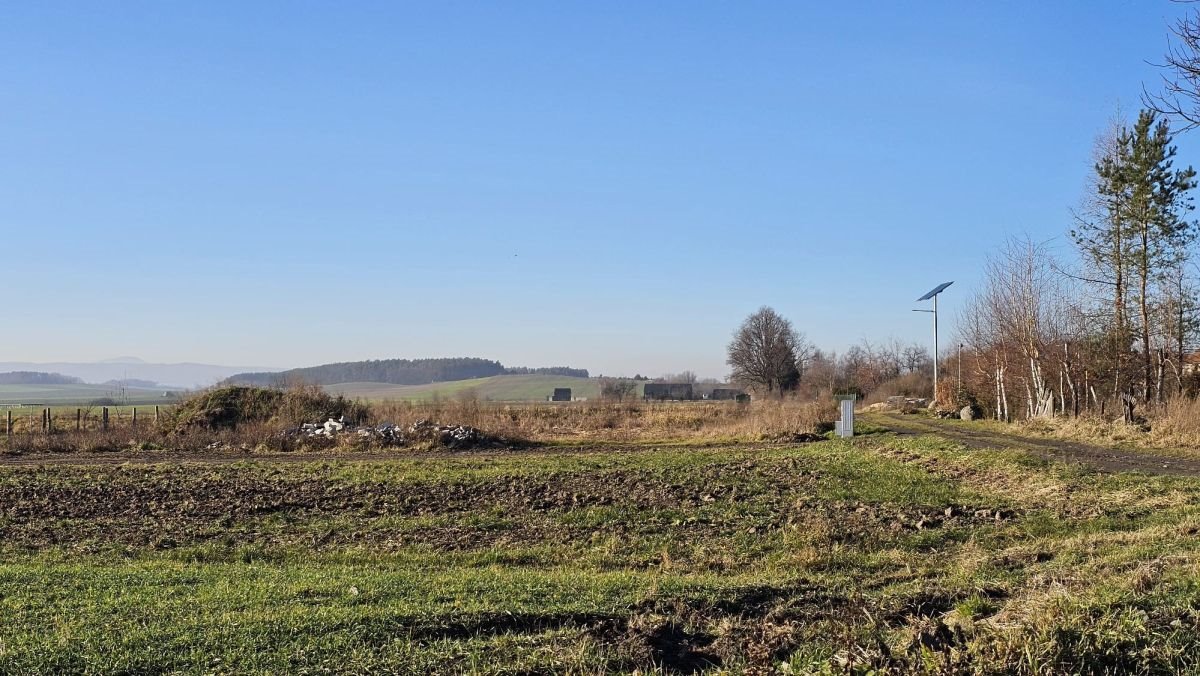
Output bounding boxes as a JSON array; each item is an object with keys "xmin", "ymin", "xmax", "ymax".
[{"xmin": 728, "ymin": 11, "xmax": 1200, "ymax": 420}]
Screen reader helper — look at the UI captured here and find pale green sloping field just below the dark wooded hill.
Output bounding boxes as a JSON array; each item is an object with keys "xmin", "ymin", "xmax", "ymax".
[{"xmin": 325, "ymin": 375, "xmax": 614, "ymax": 401}]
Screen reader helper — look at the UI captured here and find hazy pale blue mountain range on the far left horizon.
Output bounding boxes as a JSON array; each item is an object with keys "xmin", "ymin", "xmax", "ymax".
[{"xmin": 0, "ymin": 357, "xmax": 280, "ymax": 389}]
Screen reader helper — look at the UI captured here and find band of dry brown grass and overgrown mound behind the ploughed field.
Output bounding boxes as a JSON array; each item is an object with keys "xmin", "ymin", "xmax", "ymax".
[{"xmin": 0, "ymin": 390, "xmax": 836, "ymax": 453}]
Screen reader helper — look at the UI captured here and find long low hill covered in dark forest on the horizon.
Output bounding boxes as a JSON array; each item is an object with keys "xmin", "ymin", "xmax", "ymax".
[{"xmin": 226, "ymin": 357, "xmax": 588, "ymax": 387}]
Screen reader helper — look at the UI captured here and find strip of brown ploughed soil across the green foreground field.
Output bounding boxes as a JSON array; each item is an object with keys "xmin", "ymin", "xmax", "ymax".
[{"xmin": 0, "ymin": 449, "xmax": 1015, "ymax": 554}]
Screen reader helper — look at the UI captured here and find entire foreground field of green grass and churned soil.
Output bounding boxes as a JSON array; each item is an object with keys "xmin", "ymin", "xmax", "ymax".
[{"xmin": 0, "ymin": 433, "xmax": 1200, "ymax": 674}]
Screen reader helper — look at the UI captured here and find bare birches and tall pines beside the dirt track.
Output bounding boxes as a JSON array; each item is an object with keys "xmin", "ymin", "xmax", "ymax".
[{"xmin": 955, "ymin": 97, "xmax": 1200, "ymax": 420}]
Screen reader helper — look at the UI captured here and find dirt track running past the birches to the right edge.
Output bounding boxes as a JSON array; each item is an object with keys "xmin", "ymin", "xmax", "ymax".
[{"xmin": 866, "ymin": 413, "xmax": 1200, "ymax": 477}]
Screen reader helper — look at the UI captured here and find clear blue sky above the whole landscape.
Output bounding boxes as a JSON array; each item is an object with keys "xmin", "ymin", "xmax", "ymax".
[{"xmin": 0, "ymin": 0, "xmax": 1196, "ymax": 376}]
